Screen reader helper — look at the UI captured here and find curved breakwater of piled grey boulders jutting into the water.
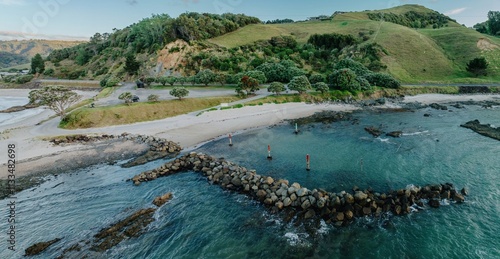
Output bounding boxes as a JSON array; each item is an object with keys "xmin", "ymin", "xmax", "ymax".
[{"xmin": 131, "ymin": 152, "xmax": 467, "ymax": 226}]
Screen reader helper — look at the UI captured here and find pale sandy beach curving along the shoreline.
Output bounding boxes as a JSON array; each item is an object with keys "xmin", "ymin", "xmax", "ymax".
[{"xmin": 0, "ymin": 90, "xmax": 500, "ymax": 179}]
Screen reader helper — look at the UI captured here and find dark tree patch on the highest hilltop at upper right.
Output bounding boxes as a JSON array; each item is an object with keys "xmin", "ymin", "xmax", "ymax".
[{"xmin": 368, "ymin": 11, "xmax": 455, "ymax": 29}]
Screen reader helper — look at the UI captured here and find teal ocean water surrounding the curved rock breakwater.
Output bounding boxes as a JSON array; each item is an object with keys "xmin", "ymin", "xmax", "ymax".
[{"xmin": 0, "ymin": 103, "xmax": 500, "ymax": 258}]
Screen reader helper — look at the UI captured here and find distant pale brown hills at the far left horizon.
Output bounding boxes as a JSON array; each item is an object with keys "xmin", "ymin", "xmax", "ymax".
[{"xmin": 0, "ymin": 40, "xmax": 82, "ymax": 68}]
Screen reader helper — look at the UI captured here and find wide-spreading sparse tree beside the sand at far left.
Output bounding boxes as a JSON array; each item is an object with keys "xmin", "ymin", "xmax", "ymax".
[{"xmin": 29, "ymin": 86, "xmax": 81, "ymax": 118}]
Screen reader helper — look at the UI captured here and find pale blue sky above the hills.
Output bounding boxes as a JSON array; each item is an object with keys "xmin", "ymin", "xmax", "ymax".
[{"xmin": 0, "ymin": 0, "xmax": 500, "ymax": 40}]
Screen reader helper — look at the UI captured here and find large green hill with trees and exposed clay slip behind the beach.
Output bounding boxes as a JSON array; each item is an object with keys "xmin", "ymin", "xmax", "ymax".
[{"xmin": 37, "ymin": 5, "xmax": 500, "ymax": 83}]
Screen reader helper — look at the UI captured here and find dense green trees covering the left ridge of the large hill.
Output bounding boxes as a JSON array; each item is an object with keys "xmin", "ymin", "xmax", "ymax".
[{"xmin": 48, "ymin": 12, "xmax": 261, "ymax": 65}]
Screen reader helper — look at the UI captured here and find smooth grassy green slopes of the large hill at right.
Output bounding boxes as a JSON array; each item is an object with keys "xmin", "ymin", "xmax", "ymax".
[{"xmin": 209, "ymin": 5, "xmax": 500, "ymax": 83}]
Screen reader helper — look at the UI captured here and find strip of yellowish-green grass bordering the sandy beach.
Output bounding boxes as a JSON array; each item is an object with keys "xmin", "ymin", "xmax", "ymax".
[{"xmin": 59, "ymin": 97, "xmax": 238, "ymax": 129}]
